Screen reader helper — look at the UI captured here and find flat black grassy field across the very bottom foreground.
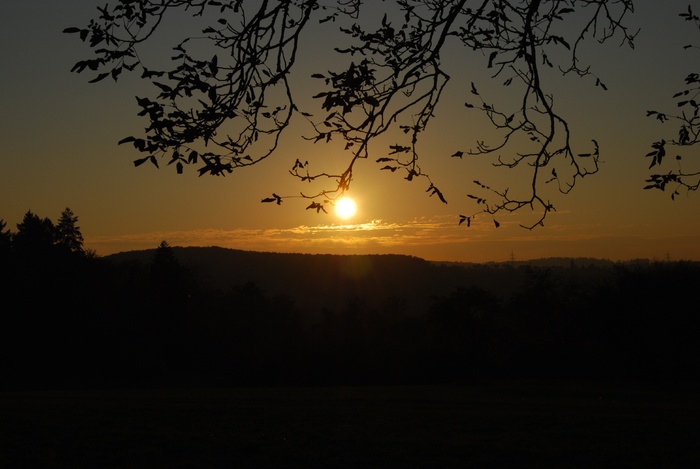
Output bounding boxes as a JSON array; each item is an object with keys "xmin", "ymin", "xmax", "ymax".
[{"xmin": 0, "ymin": 383, "xmax": 700, "ymax": 468}]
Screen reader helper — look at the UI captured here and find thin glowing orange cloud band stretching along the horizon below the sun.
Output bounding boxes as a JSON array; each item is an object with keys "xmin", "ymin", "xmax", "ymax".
[{"xmin": 86, "ymin": 216, "xmax": 700, "ymax": 262}]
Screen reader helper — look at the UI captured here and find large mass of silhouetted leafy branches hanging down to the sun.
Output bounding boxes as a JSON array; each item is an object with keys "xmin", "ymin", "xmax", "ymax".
[{"xmin": 64, "ymin": 0, "xmax": 636, "ymax": 228}]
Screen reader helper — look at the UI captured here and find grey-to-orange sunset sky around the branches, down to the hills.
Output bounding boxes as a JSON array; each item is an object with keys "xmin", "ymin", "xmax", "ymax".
[{"xmin": 0, "ymin": 0, "xmax": 700, "ymax": 262}]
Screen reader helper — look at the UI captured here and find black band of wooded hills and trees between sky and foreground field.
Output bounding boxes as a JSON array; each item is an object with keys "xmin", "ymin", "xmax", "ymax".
[{"xmin": 0, "ymin": 214, "xmax": 700, "ymax": 389}]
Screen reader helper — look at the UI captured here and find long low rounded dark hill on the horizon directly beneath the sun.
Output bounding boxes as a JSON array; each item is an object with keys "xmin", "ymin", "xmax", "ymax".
[{"xmin": 105, "ymin": 247, "xmax": 443, "ymax": 311}]
